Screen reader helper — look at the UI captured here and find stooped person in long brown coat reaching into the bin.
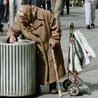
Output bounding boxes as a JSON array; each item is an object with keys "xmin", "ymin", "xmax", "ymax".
[{"xmin": 7, "ymin": 5, "xmax": 65, "ymax": 95}]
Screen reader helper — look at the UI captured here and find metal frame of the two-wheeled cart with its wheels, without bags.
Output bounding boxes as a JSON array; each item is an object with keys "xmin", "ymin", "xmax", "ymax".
[{"xmin": 63, "ymin": 23, "xmax": 91, "ymax": 96}]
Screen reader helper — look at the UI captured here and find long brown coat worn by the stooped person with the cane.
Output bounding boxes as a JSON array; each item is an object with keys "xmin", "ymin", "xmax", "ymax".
[{"xmin": 7, "ymin": 5, "xmax": 65, "ymax": 84}]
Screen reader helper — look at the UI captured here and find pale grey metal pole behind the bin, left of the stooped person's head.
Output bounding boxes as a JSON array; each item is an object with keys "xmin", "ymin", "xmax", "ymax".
[{"xmin": 9, "ymin": 0, "xmax": 15, "ymax": 26}]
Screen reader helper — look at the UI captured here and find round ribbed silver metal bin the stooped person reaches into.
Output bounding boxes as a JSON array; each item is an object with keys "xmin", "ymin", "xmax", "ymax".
[{"xmin": 0, "ymin": 40, "xmax": 36, "ymax": 96}]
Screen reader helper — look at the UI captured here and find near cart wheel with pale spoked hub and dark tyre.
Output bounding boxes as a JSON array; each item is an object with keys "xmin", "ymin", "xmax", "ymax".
[{"xmin": 68, "ymin": 84, "xmax": 80, "ymax": 96}]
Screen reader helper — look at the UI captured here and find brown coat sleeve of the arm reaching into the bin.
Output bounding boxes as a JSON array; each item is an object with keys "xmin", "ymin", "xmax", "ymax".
[{"xmin": 6, "ymin": 18, "xmax": 21, "ymax": 39}]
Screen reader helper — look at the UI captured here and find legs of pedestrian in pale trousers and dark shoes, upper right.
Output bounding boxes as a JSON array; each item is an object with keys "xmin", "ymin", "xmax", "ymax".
[{"xmin": 84, "ymin": 0, "xmax": 97, "ymax": 29}]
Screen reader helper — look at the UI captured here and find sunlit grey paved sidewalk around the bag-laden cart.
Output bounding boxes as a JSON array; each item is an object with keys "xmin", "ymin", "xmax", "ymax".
[{"xmin": 0, "ymin": 7, "xmax": 98, "ymax": 98}]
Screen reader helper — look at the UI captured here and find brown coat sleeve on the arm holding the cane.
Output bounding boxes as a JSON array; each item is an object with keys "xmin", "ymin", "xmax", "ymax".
[{"xmin": 48, "ymin": 12, "xmax": 62, "ymax": 42}]
